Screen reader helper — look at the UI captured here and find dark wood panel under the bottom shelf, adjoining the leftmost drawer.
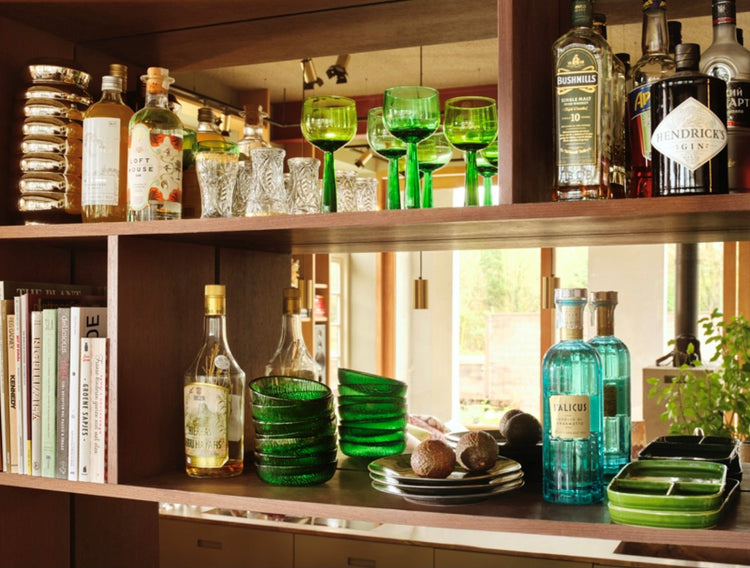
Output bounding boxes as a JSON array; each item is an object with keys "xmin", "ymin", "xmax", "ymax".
[{"xmin": 73, "ymin": 495, "xmax": 159, "ymax": 568}]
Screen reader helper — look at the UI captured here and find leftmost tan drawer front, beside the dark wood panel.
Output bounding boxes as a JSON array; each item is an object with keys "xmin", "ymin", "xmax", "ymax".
[{"xmin": 159, "ymin": 518, "xmax": 294, "ymax": 568}]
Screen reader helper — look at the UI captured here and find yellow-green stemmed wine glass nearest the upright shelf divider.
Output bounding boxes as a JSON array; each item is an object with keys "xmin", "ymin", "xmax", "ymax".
[{"xmin": 443, "ymin": 97, "xmax": 497, "ymax": 205}]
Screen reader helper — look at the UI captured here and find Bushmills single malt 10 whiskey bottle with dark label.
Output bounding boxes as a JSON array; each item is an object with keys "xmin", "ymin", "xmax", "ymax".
[{"xmin": 552, "ymin": 0, "xmax": 614, "ymax": 200}]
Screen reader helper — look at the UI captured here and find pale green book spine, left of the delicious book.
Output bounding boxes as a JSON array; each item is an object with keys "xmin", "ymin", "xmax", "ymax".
[{"xmin": 40, "ymin": 308, "xmax": 57, "ymax": 477}]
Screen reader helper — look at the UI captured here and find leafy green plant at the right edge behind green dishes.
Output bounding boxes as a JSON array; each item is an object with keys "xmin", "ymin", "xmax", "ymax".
[{"xmin": 649, "ymin": 310, "xmax": 750, "ymax": 446}]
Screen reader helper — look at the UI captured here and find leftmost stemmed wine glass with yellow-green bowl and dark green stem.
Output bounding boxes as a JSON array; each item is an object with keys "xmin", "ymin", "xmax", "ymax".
[{"xmin": 300, "ymin": 96, "xmax": 357, "ymax": 213}]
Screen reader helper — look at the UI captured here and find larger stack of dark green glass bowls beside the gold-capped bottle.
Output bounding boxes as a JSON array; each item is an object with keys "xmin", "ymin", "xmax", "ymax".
[{"xmin": 249, "ymin": 376, "xmax": 337, "ymax": 485}]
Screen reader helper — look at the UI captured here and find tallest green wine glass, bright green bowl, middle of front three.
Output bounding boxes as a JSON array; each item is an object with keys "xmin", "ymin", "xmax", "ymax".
[{"xmin": 383, "ymin": 87, "xmax": 440, "ymax": 208}]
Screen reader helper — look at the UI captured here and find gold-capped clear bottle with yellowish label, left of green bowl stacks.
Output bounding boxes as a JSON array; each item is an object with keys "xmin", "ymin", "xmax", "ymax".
[{"xmin": 184, "ymin": 284, "xmax": 245, "ymax": 477}]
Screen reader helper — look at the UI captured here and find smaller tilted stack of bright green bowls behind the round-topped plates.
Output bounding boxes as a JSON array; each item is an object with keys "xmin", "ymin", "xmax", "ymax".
[{"xmin": 338, "ymin": 369, "xmax": 408, "ymax": 458}]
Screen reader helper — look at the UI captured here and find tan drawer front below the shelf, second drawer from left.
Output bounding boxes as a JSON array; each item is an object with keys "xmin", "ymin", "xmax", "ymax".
[{"xmin": 294, "ymin": 534, "xmax": 433, "ymax": 568}]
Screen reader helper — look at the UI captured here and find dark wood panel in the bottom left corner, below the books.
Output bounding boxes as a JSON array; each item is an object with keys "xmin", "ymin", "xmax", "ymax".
[{"xmin": 0, "ymin": 487, "xmax": 71, "ymax": 568}]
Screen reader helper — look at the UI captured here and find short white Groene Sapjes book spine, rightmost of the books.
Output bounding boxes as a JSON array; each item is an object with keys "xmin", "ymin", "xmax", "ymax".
[{"xmin": 91, "ymin": 337, "xmax": 109, "ymax": 483}]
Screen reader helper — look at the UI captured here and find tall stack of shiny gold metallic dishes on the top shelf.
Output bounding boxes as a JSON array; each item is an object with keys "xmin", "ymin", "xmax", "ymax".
[{"xmin": 18, "ymin": 63, "xmax": 93, "ymax": 223}]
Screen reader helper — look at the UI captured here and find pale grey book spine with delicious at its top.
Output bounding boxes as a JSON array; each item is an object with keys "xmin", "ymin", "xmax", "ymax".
[{"xmin": 55, "ymin": 307, "xmax": 70, "ymax": 479}]
